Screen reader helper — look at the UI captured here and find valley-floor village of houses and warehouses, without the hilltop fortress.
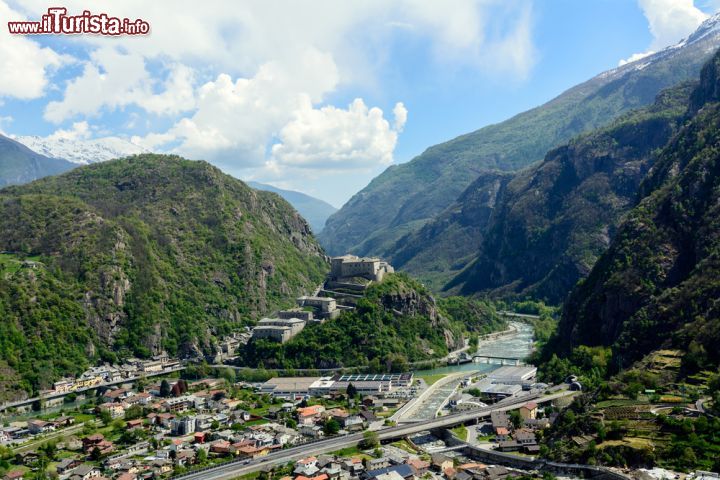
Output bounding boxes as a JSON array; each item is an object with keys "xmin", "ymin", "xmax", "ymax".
[{"xmin": 0, "ymin": 367, "xmax": 564, "ymax": 480}]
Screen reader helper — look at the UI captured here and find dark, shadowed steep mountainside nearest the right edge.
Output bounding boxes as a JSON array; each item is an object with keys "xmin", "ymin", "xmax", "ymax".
[{"xmin": 548, "ymin": 49, "xmax": 720, "ymax": 369}]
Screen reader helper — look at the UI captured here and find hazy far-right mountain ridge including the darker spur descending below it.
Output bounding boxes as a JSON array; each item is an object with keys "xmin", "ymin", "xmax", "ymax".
[{"xmin": 319, "ymin": 15, "xmax": 720, "ymax": 288}]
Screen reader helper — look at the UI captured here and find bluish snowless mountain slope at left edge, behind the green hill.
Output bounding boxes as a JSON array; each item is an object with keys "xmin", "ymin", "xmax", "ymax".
[{"xmin": 0, "ymin": 135, "xmax": 75, "ymax": 188}]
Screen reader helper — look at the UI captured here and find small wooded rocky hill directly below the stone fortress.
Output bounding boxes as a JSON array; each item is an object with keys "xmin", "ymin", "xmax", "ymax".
[{"xmin": 242, "ymin": 273, "xmax": 505, "ymax": 372}]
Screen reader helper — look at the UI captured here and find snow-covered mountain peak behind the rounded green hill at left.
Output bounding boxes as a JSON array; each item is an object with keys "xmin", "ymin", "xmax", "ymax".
[{"xmin": 15, "ymin": 135, "xmax": 148, "ymax": 165}]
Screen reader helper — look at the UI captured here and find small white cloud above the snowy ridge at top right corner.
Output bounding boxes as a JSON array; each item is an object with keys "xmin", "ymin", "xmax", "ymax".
[{"xmin": 619, "ymin": 0, "xmax": 708, "ymax": 66}]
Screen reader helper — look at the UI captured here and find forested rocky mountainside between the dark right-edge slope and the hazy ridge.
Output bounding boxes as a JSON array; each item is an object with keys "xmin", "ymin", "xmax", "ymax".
[{"xmin": 447, "ymin": 84, "xmax": 692, "ymax": 303}]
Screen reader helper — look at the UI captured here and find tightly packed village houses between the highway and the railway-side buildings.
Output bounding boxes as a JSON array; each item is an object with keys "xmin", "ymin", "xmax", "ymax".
[{"xmin": 0, "ymin": 379, "xmax": 396, "ymax": 480}]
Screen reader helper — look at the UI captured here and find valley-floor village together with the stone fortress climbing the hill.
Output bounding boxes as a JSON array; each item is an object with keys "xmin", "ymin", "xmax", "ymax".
[{"xmin": 0, "ymin": 255, "xmax": 574, "ymax": 480}]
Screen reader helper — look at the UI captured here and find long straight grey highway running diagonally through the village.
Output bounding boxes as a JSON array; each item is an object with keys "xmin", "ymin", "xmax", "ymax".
[{"xmin": 172, "ymin": 391, "xmax": 577, "ymax": 480}]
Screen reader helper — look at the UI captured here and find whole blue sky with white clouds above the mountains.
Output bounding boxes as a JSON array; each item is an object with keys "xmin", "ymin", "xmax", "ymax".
[{"xmin": 0, "ymin": 0, "xmax": 720, "ymax": 207}]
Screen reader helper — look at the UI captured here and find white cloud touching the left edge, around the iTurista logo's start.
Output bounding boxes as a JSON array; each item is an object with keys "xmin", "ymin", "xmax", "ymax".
[{"xmin": 0, "ymin": 0, "xmax": 69, "ymax": 99}]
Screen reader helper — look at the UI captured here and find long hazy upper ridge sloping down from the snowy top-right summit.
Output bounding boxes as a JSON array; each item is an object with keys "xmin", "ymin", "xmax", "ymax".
[{"xmin": 319, "ymin": 18, "xmax": 720, "ymax": 266}]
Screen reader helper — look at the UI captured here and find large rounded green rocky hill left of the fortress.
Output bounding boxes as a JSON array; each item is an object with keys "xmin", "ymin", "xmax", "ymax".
[{"xmin": 0, "ymin": 155, "xmax": 328, "ymax": 396}]
